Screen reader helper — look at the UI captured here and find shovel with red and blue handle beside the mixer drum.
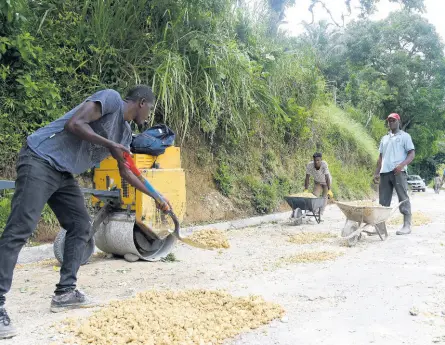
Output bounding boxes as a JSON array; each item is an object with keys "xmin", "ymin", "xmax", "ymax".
[{"xmin": 124, "ymin": 152, "xmax": 212, "ymax": 249}]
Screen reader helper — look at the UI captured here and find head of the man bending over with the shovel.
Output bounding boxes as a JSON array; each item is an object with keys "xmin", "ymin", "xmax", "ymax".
[{"xmin": 125, "ymin": 85, "xmax": 155, "ymax": 126}]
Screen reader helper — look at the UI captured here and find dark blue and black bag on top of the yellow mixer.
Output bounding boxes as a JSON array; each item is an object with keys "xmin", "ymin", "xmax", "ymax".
[{"xmin": 131, "ymin": 125, "xmax": 176, "ymax": 156}]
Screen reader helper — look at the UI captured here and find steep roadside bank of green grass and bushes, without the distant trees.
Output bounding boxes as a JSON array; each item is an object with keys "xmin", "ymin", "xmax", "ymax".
[{"xmin": 0, "ymin": 0, "xmax": 382, "ymax": 218}]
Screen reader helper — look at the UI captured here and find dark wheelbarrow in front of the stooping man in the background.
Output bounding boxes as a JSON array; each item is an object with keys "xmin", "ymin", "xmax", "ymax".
[{"xmin": 284, "ymin": 195, "xmax": 326, "ymax": 225}]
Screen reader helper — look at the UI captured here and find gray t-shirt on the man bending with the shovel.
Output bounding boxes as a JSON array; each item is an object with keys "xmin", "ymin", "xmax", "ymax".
[{"xmin": 27, "ymin": 89, "xmax": 131, "ymax": 174}]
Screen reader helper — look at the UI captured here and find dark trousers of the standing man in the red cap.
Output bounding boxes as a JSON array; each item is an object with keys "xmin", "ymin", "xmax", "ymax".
[{"xmin": 379, "ymin": 171, "xmax": 411, "ymax": 214}]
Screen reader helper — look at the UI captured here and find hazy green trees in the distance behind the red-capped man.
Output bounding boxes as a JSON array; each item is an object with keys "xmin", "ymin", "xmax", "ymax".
[{"xmin": 303, "ymin": 11, "xmax": 445, "ymax": 168}]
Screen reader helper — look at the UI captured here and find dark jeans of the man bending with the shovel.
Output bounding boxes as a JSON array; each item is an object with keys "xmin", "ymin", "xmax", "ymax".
[{"xmin": 0, "ymin": 146, "xmax": 91, "ymax": 305}]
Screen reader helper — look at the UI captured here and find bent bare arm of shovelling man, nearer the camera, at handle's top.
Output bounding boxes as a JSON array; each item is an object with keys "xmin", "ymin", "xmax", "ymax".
[{"xmin": 64, "ymin": 102, "xmax": 130, "ymax": 161}]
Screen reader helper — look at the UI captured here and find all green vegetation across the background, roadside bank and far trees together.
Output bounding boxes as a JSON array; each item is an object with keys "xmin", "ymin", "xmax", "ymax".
[{"xmin": 0, "ymin": 0, "xmax": 438, "ymax": 212}]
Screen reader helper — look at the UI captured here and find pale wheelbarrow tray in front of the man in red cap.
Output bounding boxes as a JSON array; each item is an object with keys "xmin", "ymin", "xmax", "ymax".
[{"xmin": 336, "ymin": 201, "xmax": 393, "ymax": 225}]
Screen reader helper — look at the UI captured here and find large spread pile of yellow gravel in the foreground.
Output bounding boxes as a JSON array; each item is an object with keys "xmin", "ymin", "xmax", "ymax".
[{"xmin": 58, "ymin": 290, "xmax": 284, "ymax": 345}]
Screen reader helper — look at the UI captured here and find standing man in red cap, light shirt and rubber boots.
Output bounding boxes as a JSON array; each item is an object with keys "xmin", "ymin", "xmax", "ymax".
[{"xmin": 374, "ymin": 113, "xmax": 414, "ymax": 235}]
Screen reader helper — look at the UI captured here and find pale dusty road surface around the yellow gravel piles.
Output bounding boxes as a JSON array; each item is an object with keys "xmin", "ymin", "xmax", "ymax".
[{"xmin": 1, "ymin": 190, "xmax": 445, "ymax": 345}]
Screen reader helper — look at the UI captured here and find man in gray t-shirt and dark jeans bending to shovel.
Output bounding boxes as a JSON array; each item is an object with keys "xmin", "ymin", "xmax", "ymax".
[{"xmin": 0, "ymin": 85, "xmax": 169, "ymax": 339}]
